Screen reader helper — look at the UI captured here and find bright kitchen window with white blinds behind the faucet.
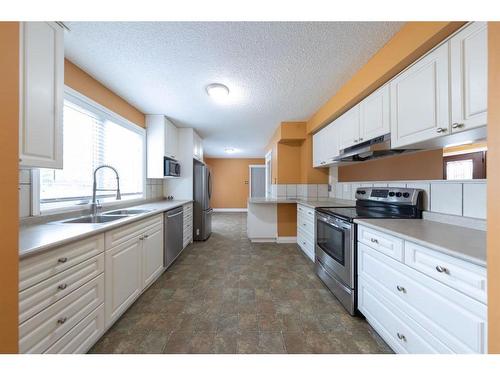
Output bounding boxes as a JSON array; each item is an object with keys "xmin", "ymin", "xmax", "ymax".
[{"xmin": 39, "ymin": 90, "xmax": 145, "ymax": 213}]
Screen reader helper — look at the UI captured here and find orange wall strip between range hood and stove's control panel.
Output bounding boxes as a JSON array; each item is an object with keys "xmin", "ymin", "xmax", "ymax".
[{"xmin": 339, "ymin": 149, "xmax": 443, "ymax": 182}]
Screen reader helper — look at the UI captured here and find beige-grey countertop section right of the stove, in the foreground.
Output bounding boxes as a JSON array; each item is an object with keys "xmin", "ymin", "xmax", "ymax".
[{"xmin": 354, "ymin": 219, "xmax": 486, "ymax": 267}]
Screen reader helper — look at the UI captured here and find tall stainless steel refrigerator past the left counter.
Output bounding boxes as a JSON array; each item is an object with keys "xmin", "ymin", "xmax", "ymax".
[{"xmin": 193, "ymin": 160, "xmax": 213, "ymax": 241}]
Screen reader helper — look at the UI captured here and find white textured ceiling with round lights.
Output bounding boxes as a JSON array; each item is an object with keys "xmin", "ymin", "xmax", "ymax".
[{"xmin": 65, "ymin": 22, "xmax": 402, "ymax": 157}]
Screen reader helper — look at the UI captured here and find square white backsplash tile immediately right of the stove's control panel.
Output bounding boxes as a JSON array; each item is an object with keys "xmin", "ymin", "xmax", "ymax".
[{"xmin": 431, "ymin": 183, "xmax": 462, "ymax": 216}]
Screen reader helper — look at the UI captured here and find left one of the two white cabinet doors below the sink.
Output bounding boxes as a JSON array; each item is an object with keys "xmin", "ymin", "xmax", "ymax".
[{"xmin": 104, "ymin": 237, "xmax": 142, "ymax": 327}]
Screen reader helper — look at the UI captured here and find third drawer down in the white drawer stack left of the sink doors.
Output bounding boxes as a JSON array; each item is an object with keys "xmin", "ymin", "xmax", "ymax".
[{"xmin": 19, "ymin": 275, "xmax": 104, "ymax": 353}]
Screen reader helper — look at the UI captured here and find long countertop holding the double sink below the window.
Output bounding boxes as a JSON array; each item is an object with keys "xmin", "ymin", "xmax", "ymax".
[{"xmin": 19, "ymin": 200, "xmax": 191, "ymax": 258}]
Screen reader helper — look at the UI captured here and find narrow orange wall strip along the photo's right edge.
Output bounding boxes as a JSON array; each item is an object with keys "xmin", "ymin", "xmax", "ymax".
[{"xmin": 487, "ymin": 22, "xmax": 500, "ymax": 354}]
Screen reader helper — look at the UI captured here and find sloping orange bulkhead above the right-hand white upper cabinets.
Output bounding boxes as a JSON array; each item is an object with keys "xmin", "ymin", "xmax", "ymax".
[{"xmin": 307, "ymin": 22, "xmax": 465, "ymax": 133}]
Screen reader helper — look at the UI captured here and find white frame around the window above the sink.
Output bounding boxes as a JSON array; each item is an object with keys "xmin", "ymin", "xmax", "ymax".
[{"xmin": 31, "ymin": 85, "xmax": 147, "ymax": 216}]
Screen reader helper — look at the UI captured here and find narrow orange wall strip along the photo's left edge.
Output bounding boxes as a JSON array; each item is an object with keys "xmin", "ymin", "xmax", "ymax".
[{"xmin": 0, "ymin": 22, "xmax": 19, "ymax": 353}]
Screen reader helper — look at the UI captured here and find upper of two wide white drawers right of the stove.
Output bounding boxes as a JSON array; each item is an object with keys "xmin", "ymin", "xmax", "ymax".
[{"xmin": 358, "ymin": 244, "xmax": 487, "ymax": 353}]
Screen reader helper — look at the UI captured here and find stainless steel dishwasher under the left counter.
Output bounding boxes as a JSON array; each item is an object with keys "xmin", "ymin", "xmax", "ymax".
[{"xmin": 163, "ymin": 207, "xmax": 184, "ymax": 267}]
